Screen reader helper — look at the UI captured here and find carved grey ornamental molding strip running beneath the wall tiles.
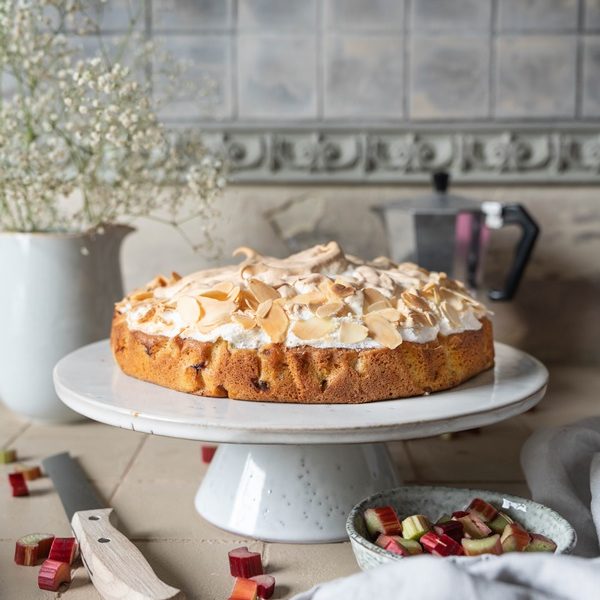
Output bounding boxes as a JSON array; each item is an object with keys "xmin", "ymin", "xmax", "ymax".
[{"xmin": 199, "ymin": 126, "xmax": 600, "ymax": 184}]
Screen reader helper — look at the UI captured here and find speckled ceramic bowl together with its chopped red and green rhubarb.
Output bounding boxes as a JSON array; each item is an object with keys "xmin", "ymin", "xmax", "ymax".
[{"xmin": 346, "ymin": 485, "xmax": 577, "ymax": 570}]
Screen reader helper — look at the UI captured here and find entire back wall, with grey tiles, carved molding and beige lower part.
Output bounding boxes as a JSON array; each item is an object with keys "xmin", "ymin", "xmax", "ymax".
[{"xmin": 82, "ymin": 0, "xmax": 600, "ymax": 364}]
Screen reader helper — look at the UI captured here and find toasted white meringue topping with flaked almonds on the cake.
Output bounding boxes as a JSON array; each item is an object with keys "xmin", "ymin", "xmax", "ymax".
[{"xmin": 117, "ymin": 242, "xmax": 488, "ymax": 349}]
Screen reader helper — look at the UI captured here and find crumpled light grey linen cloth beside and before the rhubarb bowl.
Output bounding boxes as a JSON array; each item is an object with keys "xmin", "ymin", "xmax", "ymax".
[{"xmin": 294, "ymin": 418, "xmax": 600, "ymax": 600}]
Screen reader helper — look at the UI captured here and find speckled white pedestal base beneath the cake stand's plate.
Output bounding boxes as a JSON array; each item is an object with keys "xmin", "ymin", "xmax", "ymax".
[{"xmin": 195, "ymin": 444, "xmax": 400, "ymax": 544}]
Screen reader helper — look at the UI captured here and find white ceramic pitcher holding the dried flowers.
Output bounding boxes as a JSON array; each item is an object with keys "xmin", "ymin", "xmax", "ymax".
[{"xmin": 0, "ymin": 225, "xmax": 133, "ymax": 423}]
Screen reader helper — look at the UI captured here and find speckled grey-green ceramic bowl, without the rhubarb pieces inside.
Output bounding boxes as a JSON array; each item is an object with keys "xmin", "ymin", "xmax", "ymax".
[{"xmin": 346, "ymin": 485, "xmax": 577, "ymax": 571}]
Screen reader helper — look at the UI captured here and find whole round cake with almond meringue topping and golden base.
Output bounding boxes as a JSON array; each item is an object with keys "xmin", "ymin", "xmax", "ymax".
[{"xmin": 111, "ymin": 242, "xmax": 494, "ymax": 403}]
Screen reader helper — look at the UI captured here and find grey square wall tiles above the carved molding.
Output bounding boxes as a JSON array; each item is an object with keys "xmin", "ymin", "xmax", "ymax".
[{"xmin": 91, "ymin": 0, "xmax": 600, "ymax": 125}]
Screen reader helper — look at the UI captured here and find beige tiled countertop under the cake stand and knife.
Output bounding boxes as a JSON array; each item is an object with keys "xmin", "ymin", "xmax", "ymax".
[{"xmin": 0, "ymin": 367, "xmax": 600, "ymax": 600}]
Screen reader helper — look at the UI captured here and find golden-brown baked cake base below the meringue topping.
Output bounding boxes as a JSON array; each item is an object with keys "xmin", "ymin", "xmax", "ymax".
[{"xmin": 111, "ymin": 311, "xmax": 494, "ymax": 404}]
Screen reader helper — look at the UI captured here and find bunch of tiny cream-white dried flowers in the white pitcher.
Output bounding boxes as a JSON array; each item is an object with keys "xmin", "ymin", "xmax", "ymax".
[{"xmin": 0, "ymin": 0, "xmax": 225, "ymax": 250}]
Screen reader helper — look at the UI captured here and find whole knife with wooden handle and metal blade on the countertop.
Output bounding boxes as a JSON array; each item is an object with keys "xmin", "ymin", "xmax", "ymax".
[{"xmin": 42, "ymin": 452, "xmax": 185, "ymax": 600}]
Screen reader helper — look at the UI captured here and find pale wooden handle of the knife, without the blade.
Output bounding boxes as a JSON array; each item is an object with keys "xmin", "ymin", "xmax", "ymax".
[{"xmin": 71, "ymin": 508, "xmax": 185, "ymax": 600}]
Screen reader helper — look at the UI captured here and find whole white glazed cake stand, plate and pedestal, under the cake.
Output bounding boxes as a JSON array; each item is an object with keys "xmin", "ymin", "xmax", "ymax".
[{"xmin": 54, "ymin": 341, "xmax": 548, "ymax": 543}]
